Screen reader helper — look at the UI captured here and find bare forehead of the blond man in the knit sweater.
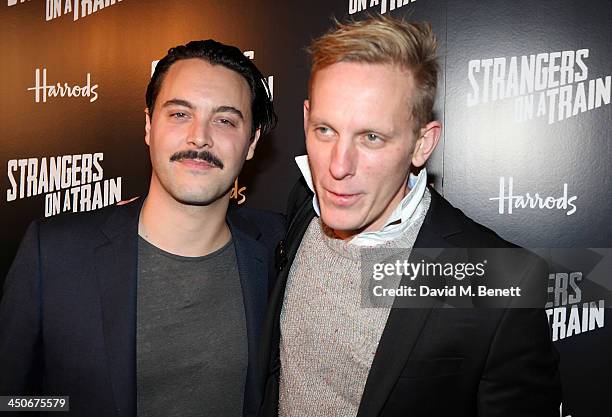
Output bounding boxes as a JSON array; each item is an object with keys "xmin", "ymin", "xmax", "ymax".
[{"xmin": 310, "ymin": 62, "xmax": 414, "ymax": 121}]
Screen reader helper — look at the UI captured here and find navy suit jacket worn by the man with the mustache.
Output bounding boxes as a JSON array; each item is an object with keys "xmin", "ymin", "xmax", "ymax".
[{"xmin": 0, "ymin": 199, "xmax": 284, "ymax": 417}]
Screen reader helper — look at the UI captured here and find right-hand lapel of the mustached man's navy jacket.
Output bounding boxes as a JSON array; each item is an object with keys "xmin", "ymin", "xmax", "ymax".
[{"xmin": 227, "ymin": 210, "xmax": 268, "ymax": 416}]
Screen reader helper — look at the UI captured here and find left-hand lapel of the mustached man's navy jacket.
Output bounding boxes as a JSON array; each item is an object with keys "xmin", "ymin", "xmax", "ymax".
[{"xmin": 94, "ymin": 199, "xmax": 144, "ymax": 417}]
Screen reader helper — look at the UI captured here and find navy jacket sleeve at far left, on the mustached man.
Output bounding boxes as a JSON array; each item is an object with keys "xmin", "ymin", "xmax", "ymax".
[{"xmin": 0, "ymin": 222, "xmax": 42, "ymax": 394}]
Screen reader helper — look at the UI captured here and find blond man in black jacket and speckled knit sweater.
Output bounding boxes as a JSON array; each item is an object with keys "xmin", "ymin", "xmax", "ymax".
[{"xmin": 260, "ymin": 17, "xmax": 560, "ymax": 417}]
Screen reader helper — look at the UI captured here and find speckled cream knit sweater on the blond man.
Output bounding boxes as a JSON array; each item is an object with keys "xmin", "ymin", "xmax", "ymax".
[{"xmin": 279, "ymin": 190, "xmax": 431, "ymax": 417}]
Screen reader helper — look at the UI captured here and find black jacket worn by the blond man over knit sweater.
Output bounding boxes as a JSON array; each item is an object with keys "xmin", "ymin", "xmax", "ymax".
[{"xmin": 260, "ymin": 182, "xmax": 561, "ymax": 417}]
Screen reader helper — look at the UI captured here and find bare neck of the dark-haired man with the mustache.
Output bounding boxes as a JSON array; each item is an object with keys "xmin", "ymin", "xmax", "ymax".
[{"xmin": 138, "ymin": 187, "xmax": 231, "ymax": 257}]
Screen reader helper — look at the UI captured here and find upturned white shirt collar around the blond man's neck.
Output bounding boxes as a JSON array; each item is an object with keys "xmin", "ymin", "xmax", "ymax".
[{"xmin": 295, "ymin": 155, "xmax": 427, "ymax": 246}]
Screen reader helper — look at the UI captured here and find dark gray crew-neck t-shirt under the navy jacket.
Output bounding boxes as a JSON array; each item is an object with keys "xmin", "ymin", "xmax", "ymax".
[{"xmin": 136, "ymin": 237, "xmax": 248, "ymax": 417}]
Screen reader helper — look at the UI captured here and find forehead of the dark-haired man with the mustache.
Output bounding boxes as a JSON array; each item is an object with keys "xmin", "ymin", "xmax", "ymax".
[{"xmin": 155, "ymin": 58, "xmax": 251, "ymax": 114}]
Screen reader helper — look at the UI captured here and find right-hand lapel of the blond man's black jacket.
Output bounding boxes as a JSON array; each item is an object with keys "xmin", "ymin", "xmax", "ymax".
[{"xmin": 357, "ymin": 188, "xmax": 461, "ymax": 417}]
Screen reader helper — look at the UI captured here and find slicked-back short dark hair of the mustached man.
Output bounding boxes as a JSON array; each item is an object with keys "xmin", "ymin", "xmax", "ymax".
[{"xmin": 146, "ymin": 39, "xmax": 277, "ymax": 137}]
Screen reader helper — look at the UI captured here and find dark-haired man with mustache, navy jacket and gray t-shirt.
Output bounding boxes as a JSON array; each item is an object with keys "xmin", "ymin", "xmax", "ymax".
[{"xmin": 0, "ymin": 40, "xmax": 283, "ymax": 417}]
